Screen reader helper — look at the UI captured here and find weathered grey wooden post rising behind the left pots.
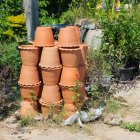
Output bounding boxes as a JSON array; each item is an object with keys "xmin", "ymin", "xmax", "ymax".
[{"xmin": 24, "ymin": 0, "xmax": 39, "ymax": 42}]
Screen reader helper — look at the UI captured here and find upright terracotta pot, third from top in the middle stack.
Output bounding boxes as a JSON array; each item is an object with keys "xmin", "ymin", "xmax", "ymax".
[{"xmin": 41, "ymin": 65, "xmax": 62, "ymax": 86}]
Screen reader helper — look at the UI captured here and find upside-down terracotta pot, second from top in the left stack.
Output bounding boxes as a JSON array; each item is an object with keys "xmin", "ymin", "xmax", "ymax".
[{"xmin": 18, "ymin": 65, "xmax": 40, "ymax": 85}]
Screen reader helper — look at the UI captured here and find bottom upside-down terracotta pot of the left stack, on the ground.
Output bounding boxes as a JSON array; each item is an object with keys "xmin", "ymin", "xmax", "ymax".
[{"xmin": 21, "ymin": 101, "xmax": 38, "ymax": 117}]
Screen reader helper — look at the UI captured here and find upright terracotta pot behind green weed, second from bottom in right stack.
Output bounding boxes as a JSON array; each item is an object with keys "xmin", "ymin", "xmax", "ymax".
[{"xmin": 61, "ymin": 86, "xmax": 83, "ymax": 104}]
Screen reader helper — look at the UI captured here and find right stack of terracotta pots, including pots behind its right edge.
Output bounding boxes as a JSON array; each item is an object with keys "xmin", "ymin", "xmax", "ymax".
[{"xmin": 58, "ymin": 26, "xmax": 87, "ymax": 119}]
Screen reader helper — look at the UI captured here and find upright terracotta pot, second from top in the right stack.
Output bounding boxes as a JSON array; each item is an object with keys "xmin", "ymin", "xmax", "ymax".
[{"xmin": 59, "ymin": 48, "xmax": 80, "ymax": 67}]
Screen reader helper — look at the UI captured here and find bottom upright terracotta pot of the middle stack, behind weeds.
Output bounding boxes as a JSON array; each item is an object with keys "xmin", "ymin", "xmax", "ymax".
[{"xmin": 39, "ymin": 99, "xmax": 61, "ymax": 118}]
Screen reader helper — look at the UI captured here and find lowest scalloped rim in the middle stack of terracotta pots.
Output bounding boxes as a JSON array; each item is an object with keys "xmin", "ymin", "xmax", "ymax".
[{"xmin": 39, "ymin": 98, "xmax": 63, "ymax": 106}]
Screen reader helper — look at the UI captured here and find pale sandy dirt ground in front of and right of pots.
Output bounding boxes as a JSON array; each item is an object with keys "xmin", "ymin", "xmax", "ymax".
[{"xmin": 0, "ymin": 80, "xmax": 140, "ymax": 140}]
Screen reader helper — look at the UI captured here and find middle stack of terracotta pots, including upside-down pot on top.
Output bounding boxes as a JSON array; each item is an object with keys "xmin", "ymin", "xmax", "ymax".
[{"xmin": 34, "ymin": 27, "xmax": 62, "ymax": 117}]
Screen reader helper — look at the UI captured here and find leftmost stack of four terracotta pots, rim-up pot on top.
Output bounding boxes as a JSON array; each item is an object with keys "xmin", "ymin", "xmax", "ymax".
[{"xmin": 18, "ymin": 45, "xmax": 41, "ymax": 117}]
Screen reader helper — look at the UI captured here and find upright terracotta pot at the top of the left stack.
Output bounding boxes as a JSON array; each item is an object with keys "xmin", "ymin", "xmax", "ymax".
[{"xmin": 18, "ymin": 45, "xmax": 40, "ymax": 66}]
